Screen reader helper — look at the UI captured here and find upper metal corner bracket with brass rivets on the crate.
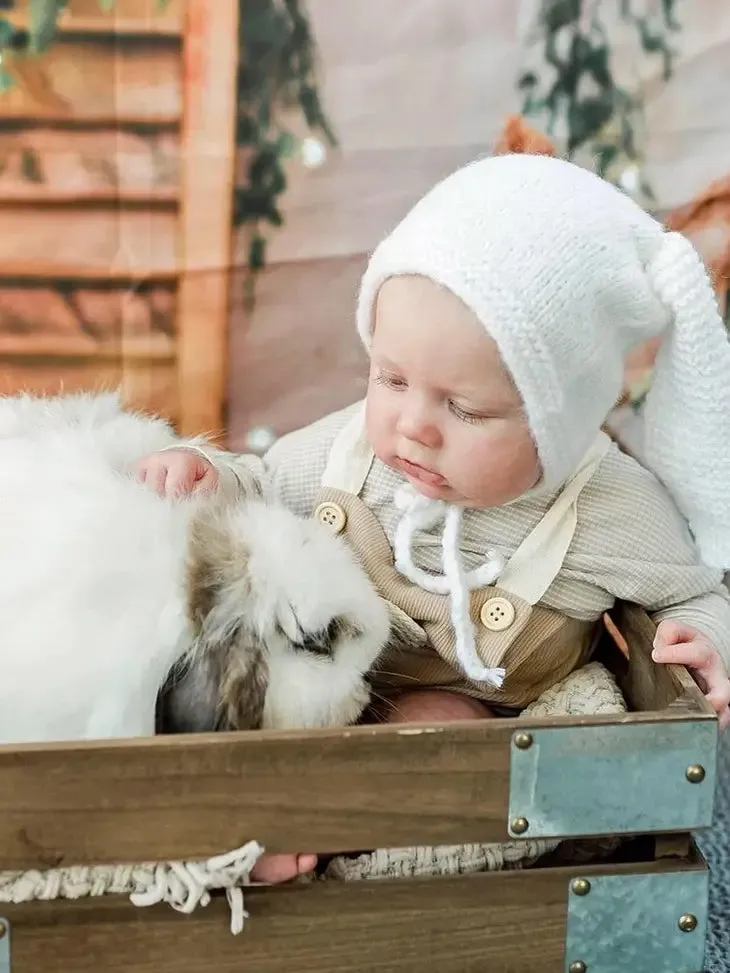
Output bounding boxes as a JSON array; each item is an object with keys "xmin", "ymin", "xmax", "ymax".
[{"xmin": 507, "ymin": 720, "xmax": 718, "ymax": 838}]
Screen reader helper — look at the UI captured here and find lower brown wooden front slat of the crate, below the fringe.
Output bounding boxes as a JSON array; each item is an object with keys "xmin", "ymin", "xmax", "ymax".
[{"xmin": 2, "ymin": 859, "xmax": 705, "ymax": 973}]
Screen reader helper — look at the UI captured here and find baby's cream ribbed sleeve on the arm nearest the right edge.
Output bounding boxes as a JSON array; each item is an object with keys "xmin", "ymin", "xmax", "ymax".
[{"xmin": 565, "ymin": 450, "xmax": 730, "ymax": 664}]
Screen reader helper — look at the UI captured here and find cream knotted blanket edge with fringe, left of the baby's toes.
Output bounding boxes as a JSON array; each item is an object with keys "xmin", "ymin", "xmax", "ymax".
[{"xmin": 0, "ymin": 841, "xmax": 264, "ymax": 936}]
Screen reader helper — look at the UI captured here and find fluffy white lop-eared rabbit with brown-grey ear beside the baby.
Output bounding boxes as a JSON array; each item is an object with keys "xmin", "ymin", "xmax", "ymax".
[{"xmin": 0, "ymin": 394, "xmax": 390, "ymax": 743}]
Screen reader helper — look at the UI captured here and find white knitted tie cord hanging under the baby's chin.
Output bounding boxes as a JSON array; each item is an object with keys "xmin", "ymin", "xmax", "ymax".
[{"xmin": 394, "ymin": 486, "xmax": 505, "ymax": 688}]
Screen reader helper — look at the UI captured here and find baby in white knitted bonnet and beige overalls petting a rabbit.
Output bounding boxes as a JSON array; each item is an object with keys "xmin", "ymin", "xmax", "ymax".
[{"xmin": 139, "ymin": 155, "xmax": 730, "ymax": 881}]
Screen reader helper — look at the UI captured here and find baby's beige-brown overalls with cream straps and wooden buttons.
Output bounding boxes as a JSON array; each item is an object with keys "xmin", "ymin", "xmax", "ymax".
[{"xmin": 315, "ymin": 412, "xmax": 610, "ymax": 708}]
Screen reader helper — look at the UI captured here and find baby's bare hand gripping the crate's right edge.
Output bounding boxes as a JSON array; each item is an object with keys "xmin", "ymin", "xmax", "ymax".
[{"xmin": 652, "ymin": 621, "xmax": 730, "ymax": 730}]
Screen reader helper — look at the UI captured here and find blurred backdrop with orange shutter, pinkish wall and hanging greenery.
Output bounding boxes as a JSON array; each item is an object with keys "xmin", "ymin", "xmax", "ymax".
[{"xmin": 0, "ymin": 0, "xmax": 730, "ymax": 449}]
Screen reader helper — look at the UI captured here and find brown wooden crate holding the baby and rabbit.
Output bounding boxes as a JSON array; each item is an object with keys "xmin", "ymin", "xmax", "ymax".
[{"xmin": 0, "ymin": 609, "xmax": 717, "ymax": 973}]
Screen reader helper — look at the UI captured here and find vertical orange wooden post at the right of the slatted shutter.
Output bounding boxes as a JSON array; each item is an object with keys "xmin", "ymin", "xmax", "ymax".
[{"xmin": 177, "ymin": 0, "xmax": 238, "ymax": 436}]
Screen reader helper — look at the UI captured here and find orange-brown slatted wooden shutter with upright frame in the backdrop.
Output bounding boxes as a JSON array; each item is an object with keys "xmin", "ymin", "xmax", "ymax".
[{"xmin": 0, "ymin": 0, "xmax": 238, "ymax": 434}]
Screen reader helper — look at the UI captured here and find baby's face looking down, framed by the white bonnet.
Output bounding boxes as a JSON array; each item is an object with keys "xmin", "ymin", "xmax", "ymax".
[{"xmin": 367, "ymin": 277, "xmax": 540, "ymax": 507}]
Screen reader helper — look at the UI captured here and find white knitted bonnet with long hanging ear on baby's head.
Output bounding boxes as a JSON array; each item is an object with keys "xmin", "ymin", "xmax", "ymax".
[{"xmin": 357, "ymin": 155, "xmax": 730, "ymax": 569}]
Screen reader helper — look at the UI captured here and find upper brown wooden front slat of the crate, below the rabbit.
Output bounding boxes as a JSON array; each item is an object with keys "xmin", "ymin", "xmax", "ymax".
[{"xmin": 0, "ymin": 696, "xmax": 702, "ymax": 868}]
